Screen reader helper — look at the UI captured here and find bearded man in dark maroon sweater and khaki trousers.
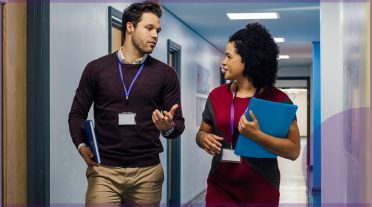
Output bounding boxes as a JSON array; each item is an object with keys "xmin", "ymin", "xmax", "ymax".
[{"xmin": 69, "ymin": 1, "xmax": 185, "ymax": 205}]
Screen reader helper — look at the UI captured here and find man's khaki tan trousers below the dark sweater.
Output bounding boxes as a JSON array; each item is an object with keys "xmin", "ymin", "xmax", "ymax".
[{"xmin": 85, "ymin": 164, "xmax": 164, "ymax": 207}]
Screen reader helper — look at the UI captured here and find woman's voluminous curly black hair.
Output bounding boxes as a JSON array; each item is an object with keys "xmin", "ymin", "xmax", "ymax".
[{"xmin": 229, "ymin": 22, "xmax": 279, "ymax": 88}]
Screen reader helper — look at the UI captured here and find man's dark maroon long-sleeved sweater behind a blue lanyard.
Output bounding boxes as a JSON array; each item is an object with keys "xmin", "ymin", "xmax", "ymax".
[{"xmin": 68, "ymin": 53, "xmax": 185, "ymax": 167}]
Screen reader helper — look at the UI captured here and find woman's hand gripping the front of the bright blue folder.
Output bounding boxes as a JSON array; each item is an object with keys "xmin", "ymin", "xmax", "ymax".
[{"xmin": 238, "ymin": 111, "xmax": 261, "ymax": 140}]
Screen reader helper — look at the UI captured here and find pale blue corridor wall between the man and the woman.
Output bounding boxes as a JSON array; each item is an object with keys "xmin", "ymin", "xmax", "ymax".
[{"xmin": 154, "ymin": 6, "xmax": 222, "ymax": 204}]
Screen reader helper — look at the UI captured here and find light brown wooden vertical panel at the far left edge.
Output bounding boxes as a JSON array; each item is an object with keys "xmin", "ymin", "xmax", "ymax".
[{"xmin": 2, "ymin": 2, "xmax": 27, "ymax": 204}]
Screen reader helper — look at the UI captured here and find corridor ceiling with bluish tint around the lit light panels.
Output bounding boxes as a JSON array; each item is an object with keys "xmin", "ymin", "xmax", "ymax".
[{"xmin": 162, "ymin": 0, "xmax": 320, "ymax": 67}]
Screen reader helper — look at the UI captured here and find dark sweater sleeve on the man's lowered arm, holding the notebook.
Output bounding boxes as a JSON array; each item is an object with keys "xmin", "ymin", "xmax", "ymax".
[{"xmin": 68, "ymin": 63, "xmax": 95, "ymax": 148}]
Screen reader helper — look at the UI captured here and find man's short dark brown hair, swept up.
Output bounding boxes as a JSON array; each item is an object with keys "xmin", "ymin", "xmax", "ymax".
[{"xmin": 121, "ymin": 1, "xmax": 163, "ymax": 39}]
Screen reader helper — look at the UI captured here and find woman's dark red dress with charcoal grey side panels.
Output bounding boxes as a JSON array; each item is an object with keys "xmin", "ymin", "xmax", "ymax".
[{"xmin": 203, "ymin": 84, "xmax": 292, "ymax": 206}]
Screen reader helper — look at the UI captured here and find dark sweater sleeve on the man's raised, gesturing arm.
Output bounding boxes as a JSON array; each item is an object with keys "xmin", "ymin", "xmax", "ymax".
[{"xmin": 162, "ymin": 69, "xmax": 185, "ymax": 139}]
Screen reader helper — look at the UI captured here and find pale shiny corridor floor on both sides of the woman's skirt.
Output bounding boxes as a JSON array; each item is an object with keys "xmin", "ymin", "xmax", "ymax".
[{"xmin": 184, "ymin": 138, "xmax": 307, "ymax": 207}]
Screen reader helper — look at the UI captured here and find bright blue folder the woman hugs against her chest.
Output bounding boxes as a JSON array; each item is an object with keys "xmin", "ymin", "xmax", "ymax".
[{"xmin": 235, "ymin": 97, "xmax": 297, "ymax": 158}]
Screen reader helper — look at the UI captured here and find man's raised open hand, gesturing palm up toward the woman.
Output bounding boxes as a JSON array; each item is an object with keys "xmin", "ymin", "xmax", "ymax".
[{"xmin": 152, "ymin": 104, "xmax": 178, "ymax": 132}]
